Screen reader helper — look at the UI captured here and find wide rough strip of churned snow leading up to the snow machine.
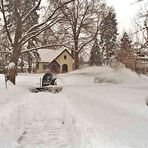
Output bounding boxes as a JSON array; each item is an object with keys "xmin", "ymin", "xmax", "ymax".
[{"xmin": 17, "ymin": 93, "xmax": 78, "ymax": 148}]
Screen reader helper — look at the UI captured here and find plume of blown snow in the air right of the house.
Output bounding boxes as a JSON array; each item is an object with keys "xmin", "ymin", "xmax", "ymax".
[{"xmin": 66, "ymin": 66, "xmax": 139, "ymax": 83}]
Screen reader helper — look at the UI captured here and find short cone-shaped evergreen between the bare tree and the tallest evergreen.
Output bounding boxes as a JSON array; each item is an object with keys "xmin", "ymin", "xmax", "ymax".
[{"xmin": 89, "ymin": 39, "xmax": 102, "ymax": 66}]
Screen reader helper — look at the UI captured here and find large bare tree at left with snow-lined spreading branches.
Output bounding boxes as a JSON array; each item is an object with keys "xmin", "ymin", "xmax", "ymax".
[{"xmin": 0, "ymin": 0, "xmax": 74, "ymax": 84}]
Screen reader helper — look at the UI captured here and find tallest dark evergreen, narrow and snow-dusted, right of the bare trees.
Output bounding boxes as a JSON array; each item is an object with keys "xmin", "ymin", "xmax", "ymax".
[{"xmin": 100, "ymin": 9, "xmax": 118, "ymax": 64}]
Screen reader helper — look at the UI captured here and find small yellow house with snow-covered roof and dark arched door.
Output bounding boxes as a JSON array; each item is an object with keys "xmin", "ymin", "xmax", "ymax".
[{"xmin": 37, "ymin": 49, "xmax": 73, "ymax": 73}]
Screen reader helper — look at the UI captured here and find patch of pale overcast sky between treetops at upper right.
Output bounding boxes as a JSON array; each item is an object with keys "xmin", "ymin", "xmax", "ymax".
[{"xmin": 106, "ymin": 0, "xmax": 139, "ymax": 32}]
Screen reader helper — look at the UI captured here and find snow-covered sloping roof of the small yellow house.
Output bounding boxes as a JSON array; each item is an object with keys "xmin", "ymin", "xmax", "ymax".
[{"xmin": 38, "ymin": 49, "xmax": 64, "ymax": 62}]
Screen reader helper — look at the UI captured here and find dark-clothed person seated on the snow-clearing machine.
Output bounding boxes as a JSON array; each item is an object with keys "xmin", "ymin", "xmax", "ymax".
[{"xmin": 42, "ymin": 69, "xmax": 57, "ymax": 86}]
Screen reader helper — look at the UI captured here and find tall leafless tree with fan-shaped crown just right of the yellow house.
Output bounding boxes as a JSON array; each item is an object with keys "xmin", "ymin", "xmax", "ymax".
[{"xmin": 48, "ymin": 0, "xmax": 106, "ymax": 69}]
